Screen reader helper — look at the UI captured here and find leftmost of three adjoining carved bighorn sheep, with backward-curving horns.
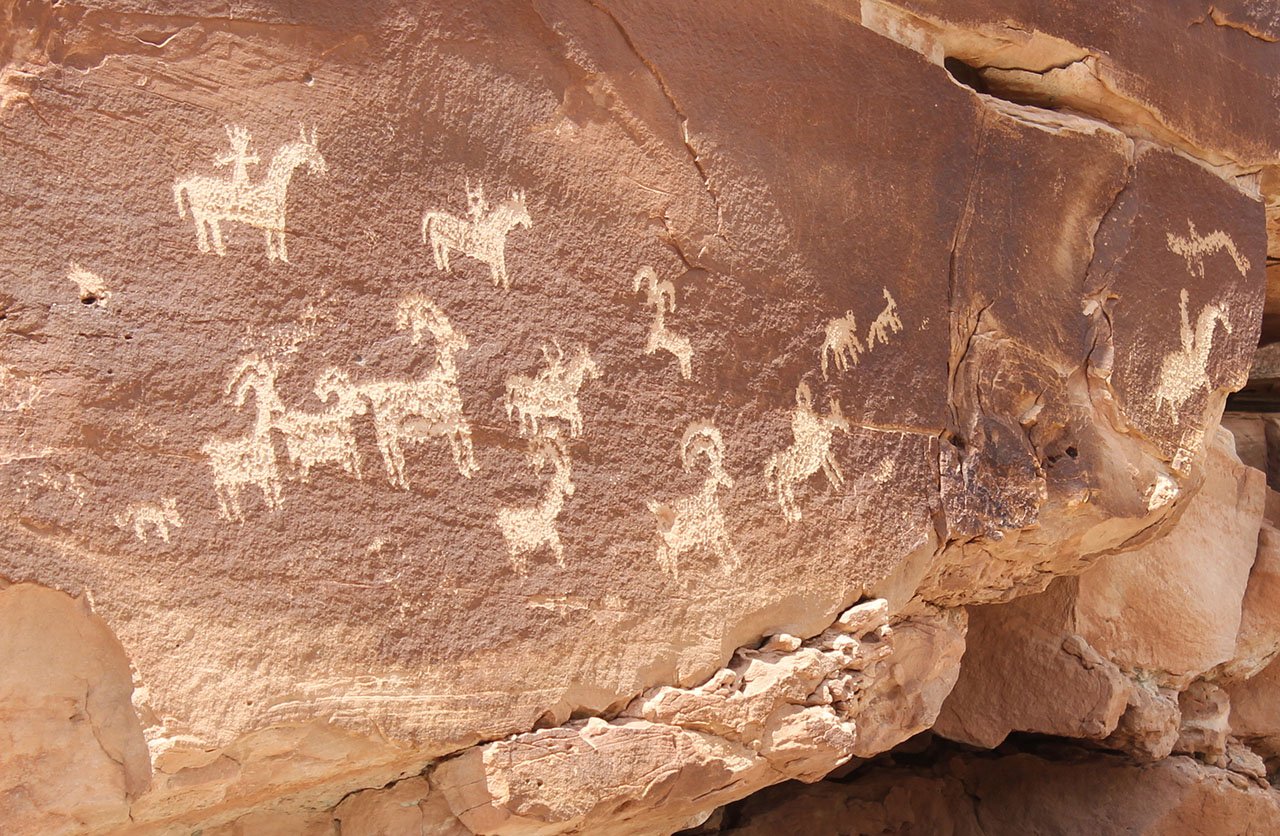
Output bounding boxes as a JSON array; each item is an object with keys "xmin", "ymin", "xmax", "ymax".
[{"xmin": 201, "ymin": 357, "xmax": 280, "ymax": 521}]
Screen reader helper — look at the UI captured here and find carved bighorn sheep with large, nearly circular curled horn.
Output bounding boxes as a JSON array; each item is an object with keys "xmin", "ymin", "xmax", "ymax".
[{"xmin": 649, "ymin": 421, "xmax": 739, "ymax": 577}]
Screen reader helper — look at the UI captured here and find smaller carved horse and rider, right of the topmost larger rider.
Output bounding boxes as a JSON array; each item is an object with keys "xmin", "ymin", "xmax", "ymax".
[{"xmin": 422, "ymin": 184, "xmax": 534, "ymax": 291}]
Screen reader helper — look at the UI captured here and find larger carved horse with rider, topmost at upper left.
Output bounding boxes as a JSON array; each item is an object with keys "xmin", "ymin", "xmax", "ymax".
[{"xmin": 173, "ymin": 125, "xmax": 329, "ymax": 261}]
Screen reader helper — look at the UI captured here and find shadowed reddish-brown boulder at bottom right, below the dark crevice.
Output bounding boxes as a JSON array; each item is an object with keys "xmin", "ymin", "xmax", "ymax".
[{"xmin": 704, "ymin": 750, "xmax": 1280, "ymax": 836}]
